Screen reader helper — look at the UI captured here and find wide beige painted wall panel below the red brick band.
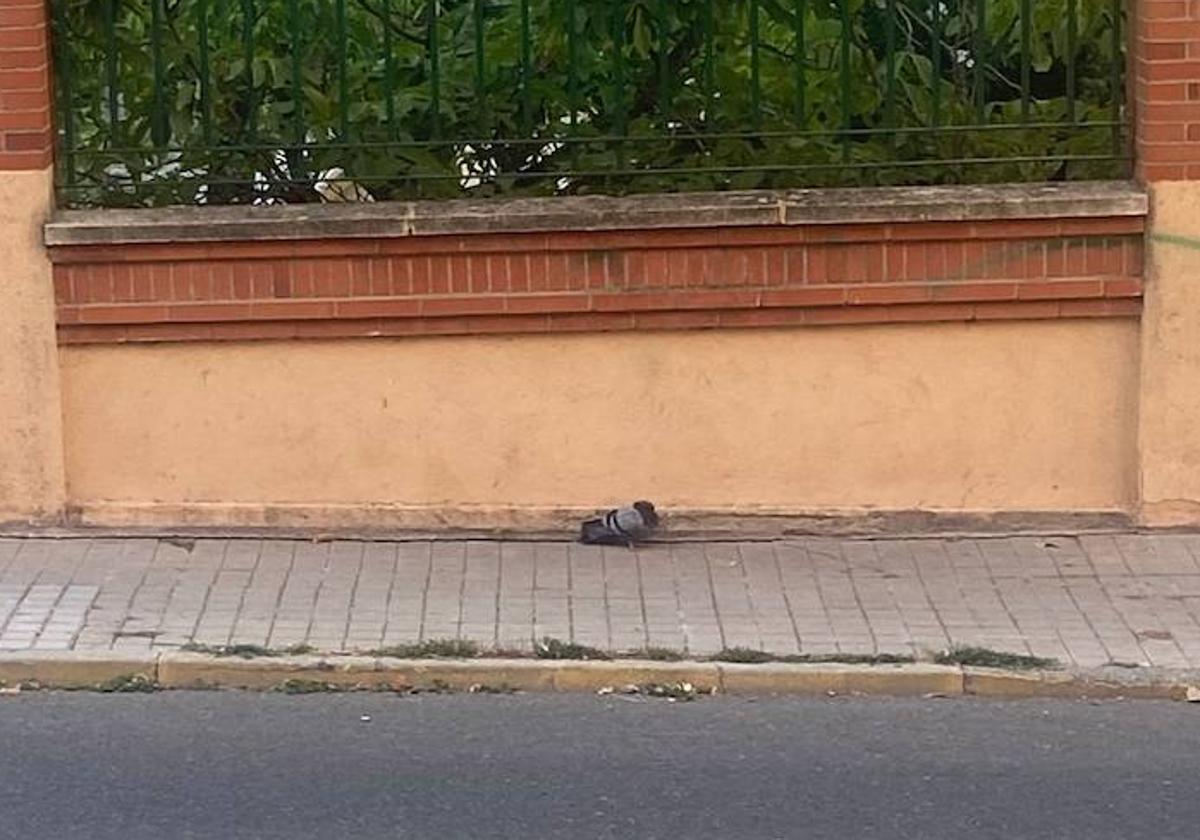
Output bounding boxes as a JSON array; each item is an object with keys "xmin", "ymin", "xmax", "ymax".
[{"xmin": 62, "ymin": 320, "xmax": 1139, "ymax": 524}]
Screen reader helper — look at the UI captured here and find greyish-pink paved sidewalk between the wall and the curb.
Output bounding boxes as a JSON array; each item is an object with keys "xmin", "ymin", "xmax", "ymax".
[{"xmin": 0, "ymin": 534, "xmax": 1200, "ymax": 667}]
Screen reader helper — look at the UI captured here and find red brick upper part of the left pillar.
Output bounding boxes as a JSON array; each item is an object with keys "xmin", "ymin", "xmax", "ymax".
[{"xmin": 0, "ymin": 0, "xmax": 53, "ymax": 172}]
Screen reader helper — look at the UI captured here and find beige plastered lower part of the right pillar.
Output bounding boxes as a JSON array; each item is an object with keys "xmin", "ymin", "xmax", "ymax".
[{"xmin": 1140, "ymin": 182, "xmax": 1200, "ymax": 526}]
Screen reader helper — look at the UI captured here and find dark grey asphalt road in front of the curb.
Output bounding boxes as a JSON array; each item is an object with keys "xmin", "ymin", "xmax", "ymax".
[{"xmin": 0, "ymin": 692, "xmax": 1200, "ymax": 840}]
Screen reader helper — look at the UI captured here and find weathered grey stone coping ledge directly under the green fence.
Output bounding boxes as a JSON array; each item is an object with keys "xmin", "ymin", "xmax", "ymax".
[{"xmin": 44, "ymin": 181, "xmax": 1148, "ymax": 246}]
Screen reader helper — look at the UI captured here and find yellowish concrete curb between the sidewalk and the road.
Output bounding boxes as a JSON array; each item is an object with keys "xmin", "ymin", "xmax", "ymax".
[{"xmin": 0, "ymin": 652, "xmax": 1196, "ymax": 700}]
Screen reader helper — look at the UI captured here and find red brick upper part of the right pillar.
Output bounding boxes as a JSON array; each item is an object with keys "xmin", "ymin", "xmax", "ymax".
[{"xmin": 1132, "ymin": 0, "xmax": 1200, "ymax": 181}]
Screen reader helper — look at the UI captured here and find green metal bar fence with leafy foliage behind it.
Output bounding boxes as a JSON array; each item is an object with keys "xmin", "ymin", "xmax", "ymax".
[{"xmin": 53, "ymin": 0, "xmax": 1128, "ymax": 205}]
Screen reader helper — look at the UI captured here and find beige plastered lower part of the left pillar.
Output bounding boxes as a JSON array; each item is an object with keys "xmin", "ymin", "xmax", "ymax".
[{"xmin": 0, "ymin": 172, "xmax": 64, "ymax": 522}]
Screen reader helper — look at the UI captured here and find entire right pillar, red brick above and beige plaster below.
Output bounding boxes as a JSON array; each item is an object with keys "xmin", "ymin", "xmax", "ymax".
[{"xmin": 1130, "ymin": 0, "xmax": 1200, "ymax": 526}]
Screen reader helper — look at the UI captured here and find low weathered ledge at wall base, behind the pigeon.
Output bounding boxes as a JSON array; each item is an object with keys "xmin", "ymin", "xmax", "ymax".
[{"xmin": 0, "ymin": 502, "xmax": 1134, "ymax": 542}]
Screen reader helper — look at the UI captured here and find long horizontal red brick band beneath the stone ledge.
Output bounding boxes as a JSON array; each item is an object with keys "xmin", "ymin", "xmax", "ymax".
[{"xmin": 50, "ymin": 216, "xmax": 1144, "ymax": 343}]
